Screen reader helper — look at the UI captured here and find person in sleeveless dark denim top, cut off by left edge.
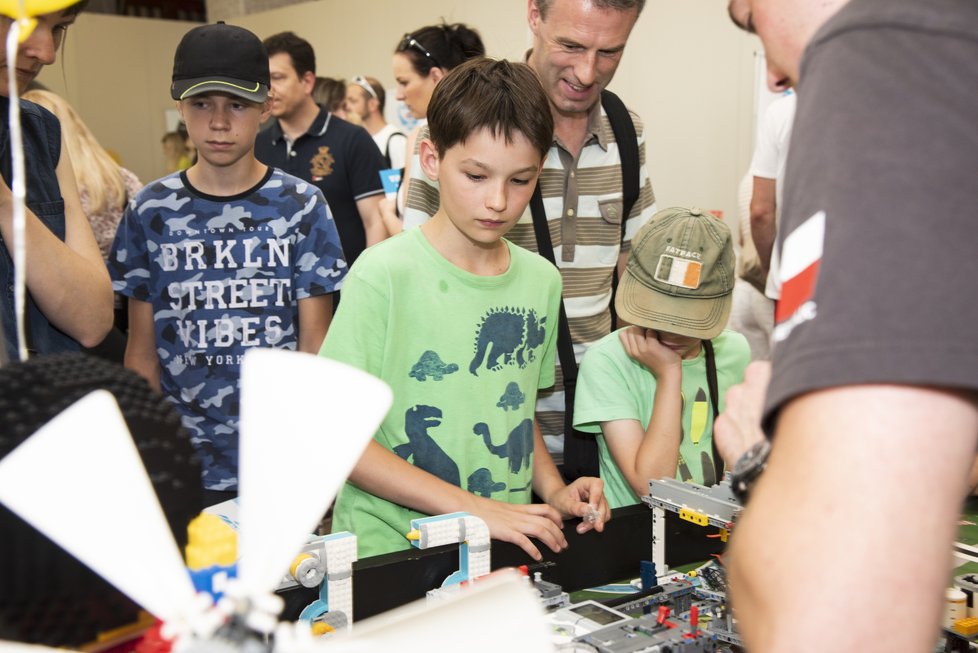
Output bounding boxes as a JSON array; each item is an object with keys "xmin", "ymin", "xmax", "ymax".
[{"xmin": 0, "ymin": 1, "xmax": 113, "ymax": 359}]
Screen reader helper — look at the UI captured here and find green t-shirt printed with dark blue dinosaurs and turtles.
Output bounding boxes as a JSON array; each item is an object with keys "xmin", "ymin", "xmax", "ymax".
[{"xmin": 320, "ymin": 229, "xmax": 560, "ymax": 557}]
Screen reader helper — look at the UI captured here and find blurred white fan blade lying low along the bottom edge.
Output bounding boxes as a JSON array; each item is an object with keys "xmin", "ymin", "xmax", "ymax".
[{"xmin": 320, "ymin": 571, "xmax": 554, "ymax": 653}]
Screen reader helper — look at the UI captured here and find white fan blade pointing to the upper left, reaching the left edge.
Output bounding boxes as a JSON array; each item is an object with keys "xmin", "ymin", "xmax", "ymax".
[{"xmin": 0, "ymin": 390, "xmax": 194, "ymax": 621}]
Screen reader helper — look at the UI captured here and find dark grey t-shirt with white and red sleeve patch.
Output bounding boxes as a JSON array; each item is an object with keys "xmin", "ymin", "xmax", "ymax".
[{"xmin": 765, "ymin": 0, "xmax": 978, "ymax": 418}]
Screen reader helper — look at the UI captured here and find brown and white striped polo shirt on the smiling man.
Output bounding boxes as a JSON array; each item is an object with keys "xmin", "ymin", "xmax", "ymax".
[{"xmin": 396, "ymin": 102, "xmax": 655, "ymax": 462}]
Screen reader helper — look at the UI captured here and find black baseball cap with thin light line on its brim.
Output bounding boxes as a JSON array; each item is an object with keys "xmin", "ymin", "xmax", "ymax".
[{"xmin": 170, "ymin": 22, "xmax": 270, "ymax": 102}]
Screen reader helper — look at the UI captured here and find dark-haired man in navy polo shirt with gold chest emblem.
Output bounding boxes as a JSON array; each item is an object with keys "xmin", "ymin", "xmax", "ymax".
[{"xmin": 255, "ymin": 32, "xmax": 387, "ymax": 265}]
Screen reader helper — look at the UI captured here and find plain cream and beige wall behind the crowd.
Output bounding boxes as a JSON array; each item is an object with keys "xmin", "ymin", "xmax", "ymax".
[{"xmin": 40, "ymin": 0, "xmax": 759, "ymax": 218}]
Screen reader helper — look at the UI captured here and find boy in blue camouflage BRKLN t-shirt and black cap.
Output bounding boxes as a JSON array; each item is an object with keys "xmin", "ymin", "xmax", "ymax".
[{"xmin": 109, "ymin": 24, "xmax": 346, "ymax": 502}]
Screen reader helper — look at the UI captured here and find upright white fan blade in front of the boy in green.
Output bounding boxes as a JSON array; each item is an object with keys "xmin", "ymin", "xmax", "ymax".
[{"xmin": 238, "ymin": 349, "xmax": 392, "ymax": 596}]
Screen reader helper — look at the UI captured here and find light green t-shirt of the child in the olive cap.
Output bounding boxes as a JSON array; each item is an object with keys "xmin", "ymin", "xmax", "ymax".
[{"xmin": 574, "ymin": 331, "xmax": 750, "ymax": 508}]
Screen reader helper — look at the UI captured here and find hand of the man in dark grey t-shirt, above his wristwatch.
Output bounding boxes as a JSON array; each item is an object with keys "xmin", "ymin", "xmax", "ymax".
[{"xmin": 713, "ymin": 361, "xmax": 771, "ymax": 469}]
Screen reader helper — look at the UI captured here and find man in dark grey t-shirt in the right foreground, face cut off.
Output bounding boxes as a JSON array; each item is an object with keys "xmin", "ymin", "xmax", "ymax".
[{"xmin": 715, "ymin": 0, "xmax": 978, "ymax": 653}]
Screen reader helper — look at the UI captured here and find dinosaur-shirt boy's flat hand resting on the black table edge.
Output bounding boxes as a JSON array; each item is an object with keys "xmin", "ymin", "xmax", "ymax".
[{"xmin": 469, "ymin": 497, "xmax": 567, "ymax": 560}]
